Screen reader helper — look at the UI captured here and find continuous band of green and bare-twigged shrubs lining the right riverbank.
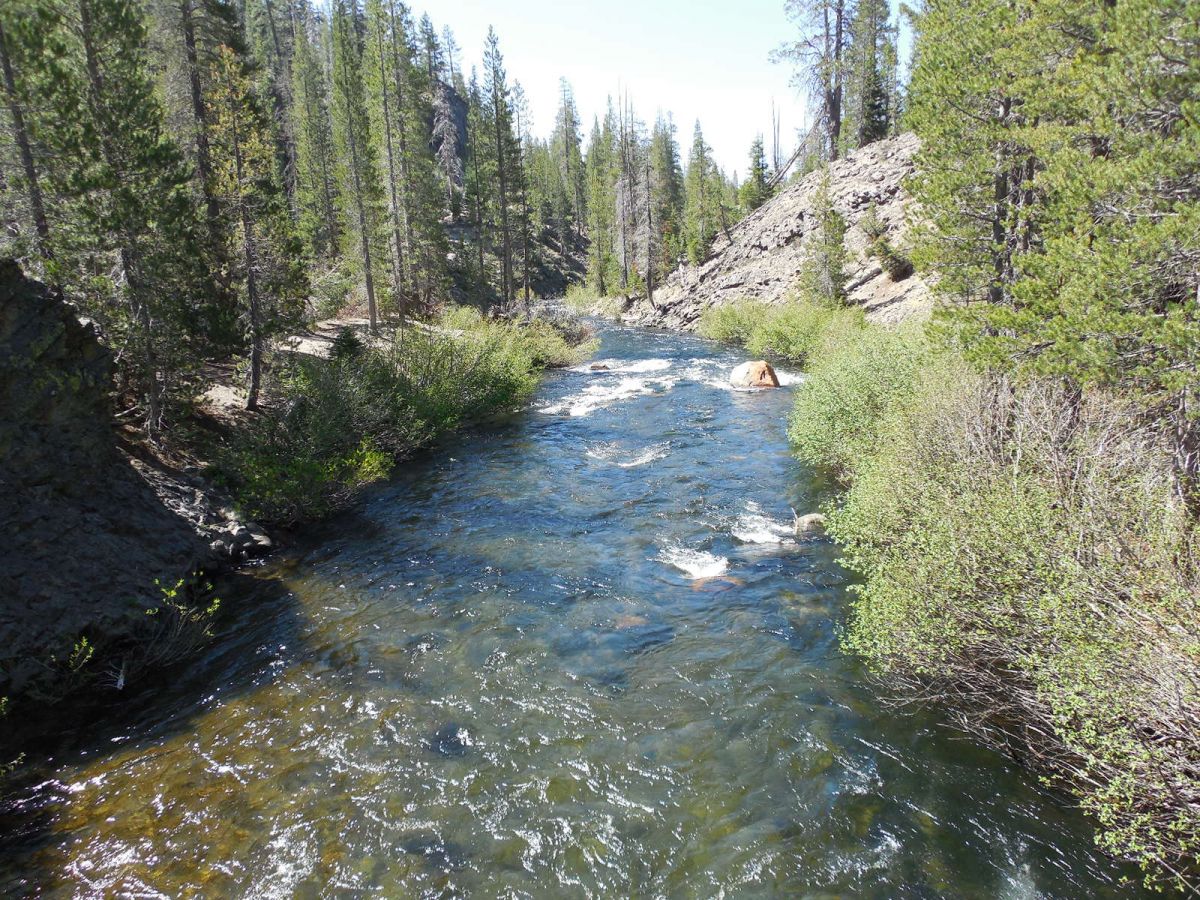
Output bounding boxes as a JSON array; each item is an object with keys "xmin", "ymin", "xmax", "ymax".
[{"xmin": 702, "ymin": 297, "xmax": 1200, "ymax": 890}]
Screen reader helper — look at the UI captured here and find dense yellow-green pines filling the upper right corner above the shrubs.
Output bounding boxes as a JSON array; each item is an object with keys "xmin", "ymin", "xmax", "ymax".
[{"xmin": 910, "ymin": 0, "xmax": 1200, "ymax": 515}]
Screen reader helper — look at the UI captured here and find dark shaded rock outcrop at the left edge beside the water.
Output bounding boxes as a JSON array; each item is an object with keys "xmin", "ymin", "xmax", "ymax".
[{"xmin": 0, "ymin": 260, "xmax": 257, "ymax": 697}]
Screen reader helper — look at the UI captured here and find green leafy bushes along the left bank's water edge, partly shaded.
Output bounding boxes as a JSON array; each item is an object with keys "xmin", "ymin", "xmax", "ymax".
[{"xmin": 221, "ymin": 310, "xmax": 544, "ymax": 523}]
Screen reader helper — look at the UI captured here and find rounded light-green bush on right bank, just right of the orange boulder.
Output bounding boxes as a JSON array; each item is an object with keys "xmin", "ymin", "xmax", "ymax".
[{"xmin": 788, "ymin": 326, "xmax": 935, "ymax": 479}]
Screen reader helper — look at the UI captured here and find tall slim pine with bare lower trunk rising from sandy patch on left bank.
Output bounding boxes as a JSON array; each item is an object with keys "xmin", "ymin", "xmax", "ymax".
[{"xmin": 332, "ymin": 0, "xmax": 383, "ymax": 331}]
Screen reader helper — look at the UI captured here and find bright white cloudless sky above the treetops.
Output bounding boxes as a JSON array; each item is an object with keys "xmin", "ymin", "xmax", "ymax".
[{"xmin": 413, "ymin": 0, "xmax": 805, "ymax": 181}]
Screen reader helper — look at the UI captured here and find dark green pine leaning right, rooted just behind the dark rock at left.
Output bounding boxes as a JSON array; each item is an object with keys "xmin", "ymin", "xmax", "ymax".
[{"xmin": 56, "ymin": 0, "xmax": 202, "ymax": 439}]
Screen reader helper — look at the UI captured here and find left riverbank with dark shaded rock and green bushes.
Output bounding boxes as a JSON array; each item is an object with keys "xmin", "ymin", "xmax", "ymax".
[{"xmin": 0, "ymin": 263, "xmax": 587, "ymax": 716}]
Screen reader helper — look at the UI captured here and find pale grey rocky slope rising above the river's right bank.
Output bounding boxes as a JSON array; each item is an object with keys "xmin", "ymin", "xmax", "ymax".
[{"xmin": 624, "ymin": 134, "xmax": 932, "ymax": 329}]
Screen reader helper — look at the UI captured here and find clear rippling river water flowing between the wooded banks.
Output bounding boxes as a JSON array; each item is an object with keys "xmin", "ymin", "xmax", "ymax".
[{"xmin": 0, "ymin": 329, "xmax": 1152, "ymax": 898}]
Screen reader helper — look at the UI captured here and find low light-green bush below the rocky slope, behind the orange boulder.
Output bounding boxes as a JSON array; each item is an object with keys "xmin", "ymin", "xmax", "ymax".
[{"xmin": 700, "ymin": 300, "xmax": 863, "ymax": 365}]
